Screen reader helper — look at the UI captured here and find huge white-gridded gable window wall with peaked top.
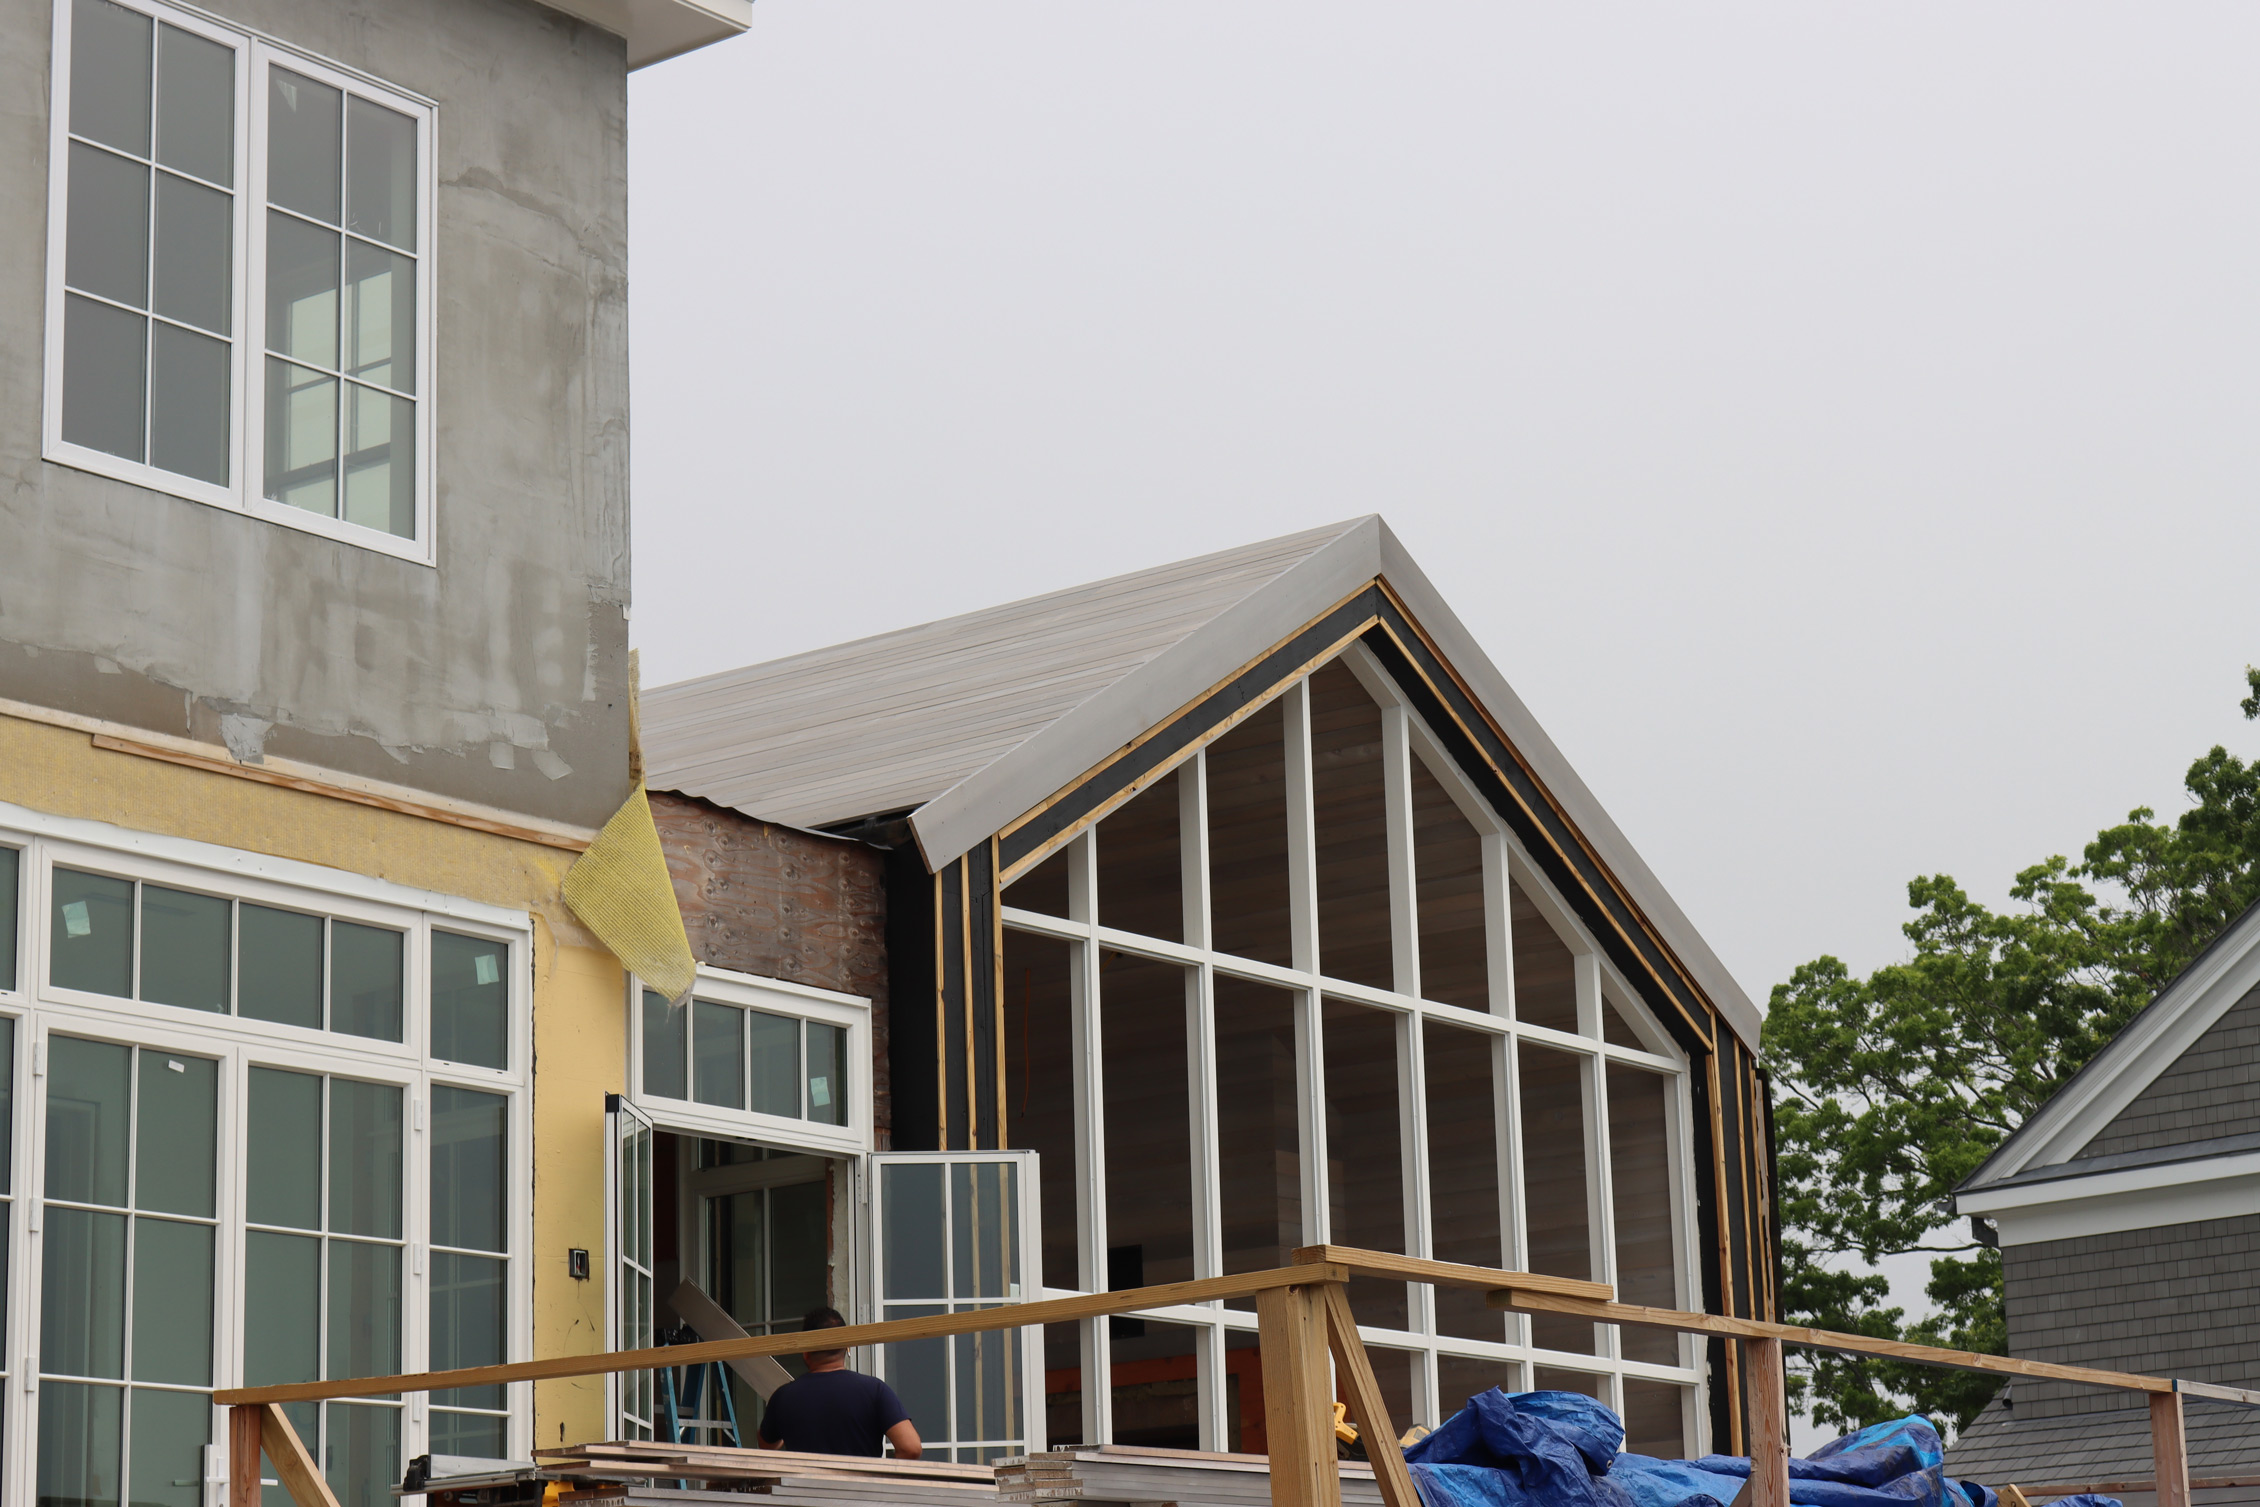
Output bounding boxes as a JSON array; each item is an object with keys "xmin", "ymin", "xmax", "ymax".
[{"xmin": 1003, "ymin": 646, "xmax": 1702, "ymax": 1455}]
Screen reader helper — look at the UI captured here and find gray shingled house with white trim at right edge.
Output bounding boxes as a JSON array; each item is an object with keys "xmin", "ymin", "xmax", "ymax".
[{"xmin": 1948, "ymin": 906, "xmax": 2260, "ymax": 1507}]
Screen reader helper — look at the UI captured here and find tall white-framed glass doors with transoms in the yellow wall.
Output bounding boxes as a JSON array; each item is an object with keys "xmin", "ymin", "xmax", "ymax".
[{"xmin": 0, "ymin": 807, "xmax": 531, "ymax": 1507}]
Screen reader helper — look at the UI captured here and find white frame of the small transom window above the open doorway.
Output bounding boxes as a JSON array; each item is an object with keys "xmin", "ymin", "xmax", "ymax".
[{"xmin": 626, "ymin": 962, "xmax": 877, "ymax": 1157}]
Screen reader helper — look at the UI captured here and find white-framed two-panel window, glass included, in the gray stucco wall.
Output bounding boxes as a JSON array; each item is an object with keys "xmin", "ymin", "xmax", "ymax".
[{"xmin": 45, "ymin": 0, "xmax": 432, "ymax": 560}]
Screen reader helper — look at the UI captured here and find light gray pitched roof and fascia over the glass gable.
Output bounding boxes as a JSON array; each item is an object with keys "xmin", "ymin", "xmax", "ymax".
[{"xmin": 642, "ymin": 515, "xmax": 1761, "ymax": 1046}]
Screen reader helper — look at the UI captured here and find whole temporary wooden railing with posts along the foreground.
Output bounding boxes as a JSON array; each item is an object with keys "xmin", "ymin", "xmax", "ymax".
[{"xmin": 212, "ymin": 1245, "xmax": 2260, "ymax": 1507}]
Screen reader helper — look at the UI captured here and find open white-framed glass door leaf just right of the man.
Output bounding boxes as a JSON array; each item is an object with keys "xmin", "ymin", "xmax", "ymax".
[{"xmin": 868, "ymin": 1152, "xmax": 1044, "ymax": 1464}]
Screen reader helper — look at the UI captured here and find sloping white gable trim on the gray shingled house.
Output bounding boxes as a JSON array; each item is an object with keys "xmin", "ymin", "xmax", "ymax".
[{"xmin": 1962, "ymin": 906, "xmax": 2260, "ymax": 1193}]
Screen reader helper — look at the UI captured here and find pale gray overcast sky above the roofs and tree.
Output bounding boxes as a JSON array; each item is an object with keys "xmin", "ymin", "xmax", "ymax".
[{"xmin": 631, "ymin": 0, "xmax": 2260, "ymax": 1021}]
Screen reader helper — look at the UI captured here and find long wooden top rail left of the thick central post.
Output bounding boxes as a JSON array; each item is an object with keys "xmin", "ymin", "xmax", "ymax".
[{"xmin": 212, "ymin": 1265, "xmax": 1349, "ymax": 1408}]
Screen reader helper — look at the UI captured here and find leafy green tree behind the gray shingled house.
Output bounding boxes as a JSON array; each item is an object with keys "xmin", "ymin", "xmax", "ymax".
[{"xmin": 1765, "ymin": 669, "xmax": 2260, "ymax": 1428}]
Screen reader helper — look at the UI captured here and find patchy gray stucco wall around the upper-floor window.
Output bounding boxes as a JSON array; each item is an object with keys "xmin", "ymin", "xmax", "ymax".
[{"xmin": 0, "ymin": 0, "xmax": 628, "ymax": 825}]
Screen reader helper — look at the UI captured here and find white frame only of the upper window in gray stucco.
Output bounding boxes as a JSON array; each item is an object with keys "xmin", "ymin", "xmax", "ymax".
[{"xmin": 41, "ymin": 0, "xmax": 438, "ymax": 565}]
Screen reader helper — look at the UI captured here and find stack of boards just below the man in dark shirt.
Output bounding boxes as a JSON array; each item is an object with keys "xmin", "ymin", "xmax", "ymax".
[{"xmin": 536, "ymin": 1441, "xmax": 997, "ymax": 1507}]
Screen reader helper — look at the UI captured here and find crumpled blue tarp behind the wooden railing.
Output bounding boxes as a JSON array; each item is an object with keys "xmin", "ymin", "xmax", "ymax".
[{"xmin": 1406, "ymin": 1387, "xmax": 2120, "ymax": 1507}]
